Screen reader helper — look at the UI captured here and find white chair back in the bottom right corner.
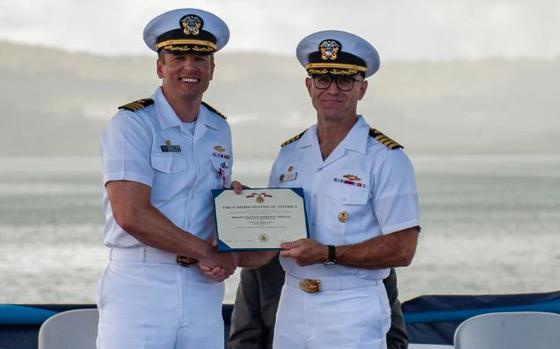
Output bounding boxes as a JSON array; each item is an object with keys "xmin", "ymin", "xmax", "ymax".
[{"xmin": 453, "ymin": 312, "xmax": 560, "ymax": 349}]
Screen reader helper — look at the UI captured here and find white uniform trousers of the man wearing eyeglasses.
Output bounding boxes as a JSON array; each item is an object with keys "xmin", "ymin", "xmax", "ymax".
[{"xmin": 273, "ymin": 274, "xmax": 391, "ymax": 349}]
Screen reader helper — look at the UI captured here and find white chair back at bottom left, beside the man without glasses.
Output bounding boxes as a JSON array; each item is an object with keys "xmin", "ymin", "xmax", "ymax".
[{"xmin": 39, "ymin": 309, "xmax": 99, "ymax": 349}]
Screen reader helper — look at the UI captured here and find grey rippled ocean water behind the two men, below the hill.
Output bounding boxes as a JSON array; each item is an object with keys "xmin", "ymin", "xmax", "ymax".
[{"xmin": 0, "ymin": 155, "xmax": 560, "ymax": 303}]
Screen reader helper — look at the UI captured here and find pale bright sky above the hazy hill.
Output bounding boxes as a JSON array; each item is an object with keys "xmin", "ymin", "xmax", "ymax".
[{"xmin": 0, "ymin": 0, "xmax": 560, "ymax": 61}]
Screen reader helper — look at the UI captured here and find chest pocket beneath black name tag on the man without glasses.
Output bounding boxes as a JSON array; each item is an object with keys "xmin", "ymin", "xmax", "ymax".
[{"xmin": 151, "ymin": 153, "xmax": 187, "ymax": 201}]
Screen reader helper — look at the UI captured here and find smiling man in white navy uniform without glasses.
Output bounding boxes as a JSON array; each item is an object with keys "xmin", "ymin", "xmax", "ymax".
[{"xmin": 97, "ymin": 9, "xmax": 237, "ymax": 349}]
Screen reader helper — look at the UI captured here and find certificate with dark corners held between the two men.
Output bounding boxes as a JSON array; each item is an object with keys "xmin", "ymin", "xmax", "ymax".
[{"xmin": 212, "ymin": 188, "xmax": 309, "ymax": 251}]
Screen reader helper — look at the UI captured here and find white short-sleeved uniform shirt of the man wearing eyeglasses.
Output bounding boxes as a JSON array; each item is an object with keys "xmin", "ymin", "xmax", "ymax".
[{"xmin": 269, "ymin": 116, "xmax": 420, "ymax": 280}]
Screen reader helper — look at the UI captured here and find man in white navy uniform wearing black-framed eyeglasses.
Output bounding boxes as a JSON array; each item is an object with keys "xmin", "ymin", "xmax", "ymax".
[{"xmin": 269, "ymin": 31, "xmax": 420, "ymax": 349}]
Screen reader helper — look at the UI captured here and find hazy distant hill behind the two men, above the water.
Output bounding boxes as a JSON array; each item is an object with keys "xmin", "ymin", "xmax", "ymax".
[{"xmin": 0, "ymin": 41, "xmax": 560, "ymax": 157}]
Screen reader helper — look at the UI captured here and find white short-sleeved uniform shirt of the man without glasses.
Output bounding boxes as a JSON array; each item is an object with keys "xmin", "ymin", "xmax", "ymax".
[{"xmin": 101, "ymin": 88, "xmax": 232, "ymax": 248}]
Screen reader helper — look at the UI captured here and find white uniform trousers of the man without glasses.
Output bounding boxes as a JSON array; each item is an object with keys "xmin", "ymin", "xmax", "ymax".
[{"xmin": 97, "ymin": 248, "xmax": 224, "ymax": 349}]
